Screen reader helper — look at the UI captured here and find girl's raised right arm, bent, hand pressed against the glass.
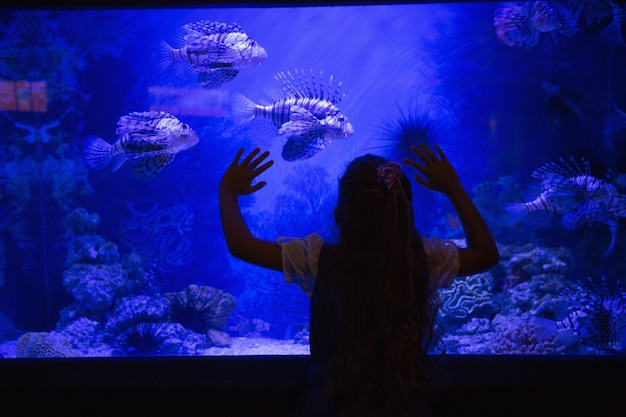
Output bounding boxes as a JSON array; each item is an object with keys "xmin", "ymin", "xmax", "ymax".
[{"xmin": 404, "ymin": 143, "xmax": 500, "ymax": 275}]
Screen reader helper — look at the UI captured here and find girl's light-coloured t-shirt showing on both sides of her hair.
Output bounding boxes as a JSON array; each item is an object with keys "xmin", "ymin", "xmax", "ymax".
[{"xmin": 276, "ymin": 233, "xmax": 459, "ymax": 297}]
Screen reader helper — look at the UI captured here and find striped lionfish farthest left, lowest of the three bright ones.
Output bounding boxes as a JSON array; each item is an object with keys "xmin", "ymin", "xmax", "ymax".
[{"xmin": 83, "ymin": 111, "xmax": 199, "ymax": 181}]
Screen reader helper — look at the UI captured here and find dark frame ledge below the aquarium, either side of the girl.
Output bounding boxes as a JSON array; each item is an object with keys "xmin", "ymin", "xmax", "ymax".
[{"xmin": 0, "ymin": 356, "xmax": 626, "ymax": 417}]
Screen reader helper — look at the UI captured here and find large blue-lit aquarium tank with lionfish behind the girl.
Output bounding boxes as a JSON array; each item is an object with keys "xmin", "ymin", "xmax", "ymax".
[{"xmin": 0, "ymin": 0, "xmax": 626, "ymax": 358}]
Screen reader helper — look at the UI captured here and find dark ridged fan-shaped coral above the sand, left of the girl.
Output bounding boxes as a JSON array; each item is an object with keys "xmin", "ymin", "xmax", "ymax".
[{"xmin": 165, "ymin": 284, "xmax": 237, "ymax": 334}]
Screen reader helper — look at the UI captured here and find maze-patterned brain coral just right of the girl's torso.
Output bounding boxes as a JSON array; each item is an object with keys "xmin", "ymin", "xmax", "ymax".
[{"xmin": 439, "ymin": 273, "xmax": 499, "ymax": 325}]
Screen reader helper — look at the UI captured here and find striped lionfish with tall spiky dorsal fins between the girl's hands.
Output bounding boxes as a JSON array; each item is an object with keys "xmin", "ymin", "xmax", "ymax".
[{"xmin": 232, "ymin": 70, "xmax": 354, "ymax": 161}]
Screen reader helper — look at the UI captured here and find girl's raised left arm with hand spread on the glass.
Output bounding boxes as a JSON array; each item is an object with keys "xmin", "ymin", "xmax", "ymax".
[{"xmin": 219, "ymin": 148, "xmax": 282, "ymax": 271}]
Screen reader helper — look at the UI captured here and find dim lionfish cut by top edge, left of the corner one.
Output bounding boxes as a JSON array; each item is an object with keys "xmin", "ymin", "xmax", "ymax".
[{"xmin": 493, "ymin": 1, "xmax": 577, "ymax": 51}]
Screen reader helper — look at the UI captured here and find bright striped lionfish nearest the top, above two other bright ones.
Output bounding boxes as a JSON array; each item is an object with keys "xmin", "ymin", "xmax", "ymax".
[{"xmin": 161, "ymin": 20, "xmax": 267, "ymax": 89}]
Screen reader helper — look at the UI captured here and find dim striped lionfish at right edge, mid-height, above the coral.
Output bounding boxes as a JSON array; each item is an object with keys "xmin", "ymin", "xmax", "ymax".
[{"xmin": 505, "ymin": 158, "xmax": 626, "ymax": 257}]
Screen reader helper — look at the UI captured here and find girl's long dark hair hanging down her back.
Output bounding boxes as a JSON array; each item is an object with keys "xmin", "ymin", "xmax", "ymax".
[{"xmin": 329, "ymin": 154, "xmax": 436, "ymax": 417}]
